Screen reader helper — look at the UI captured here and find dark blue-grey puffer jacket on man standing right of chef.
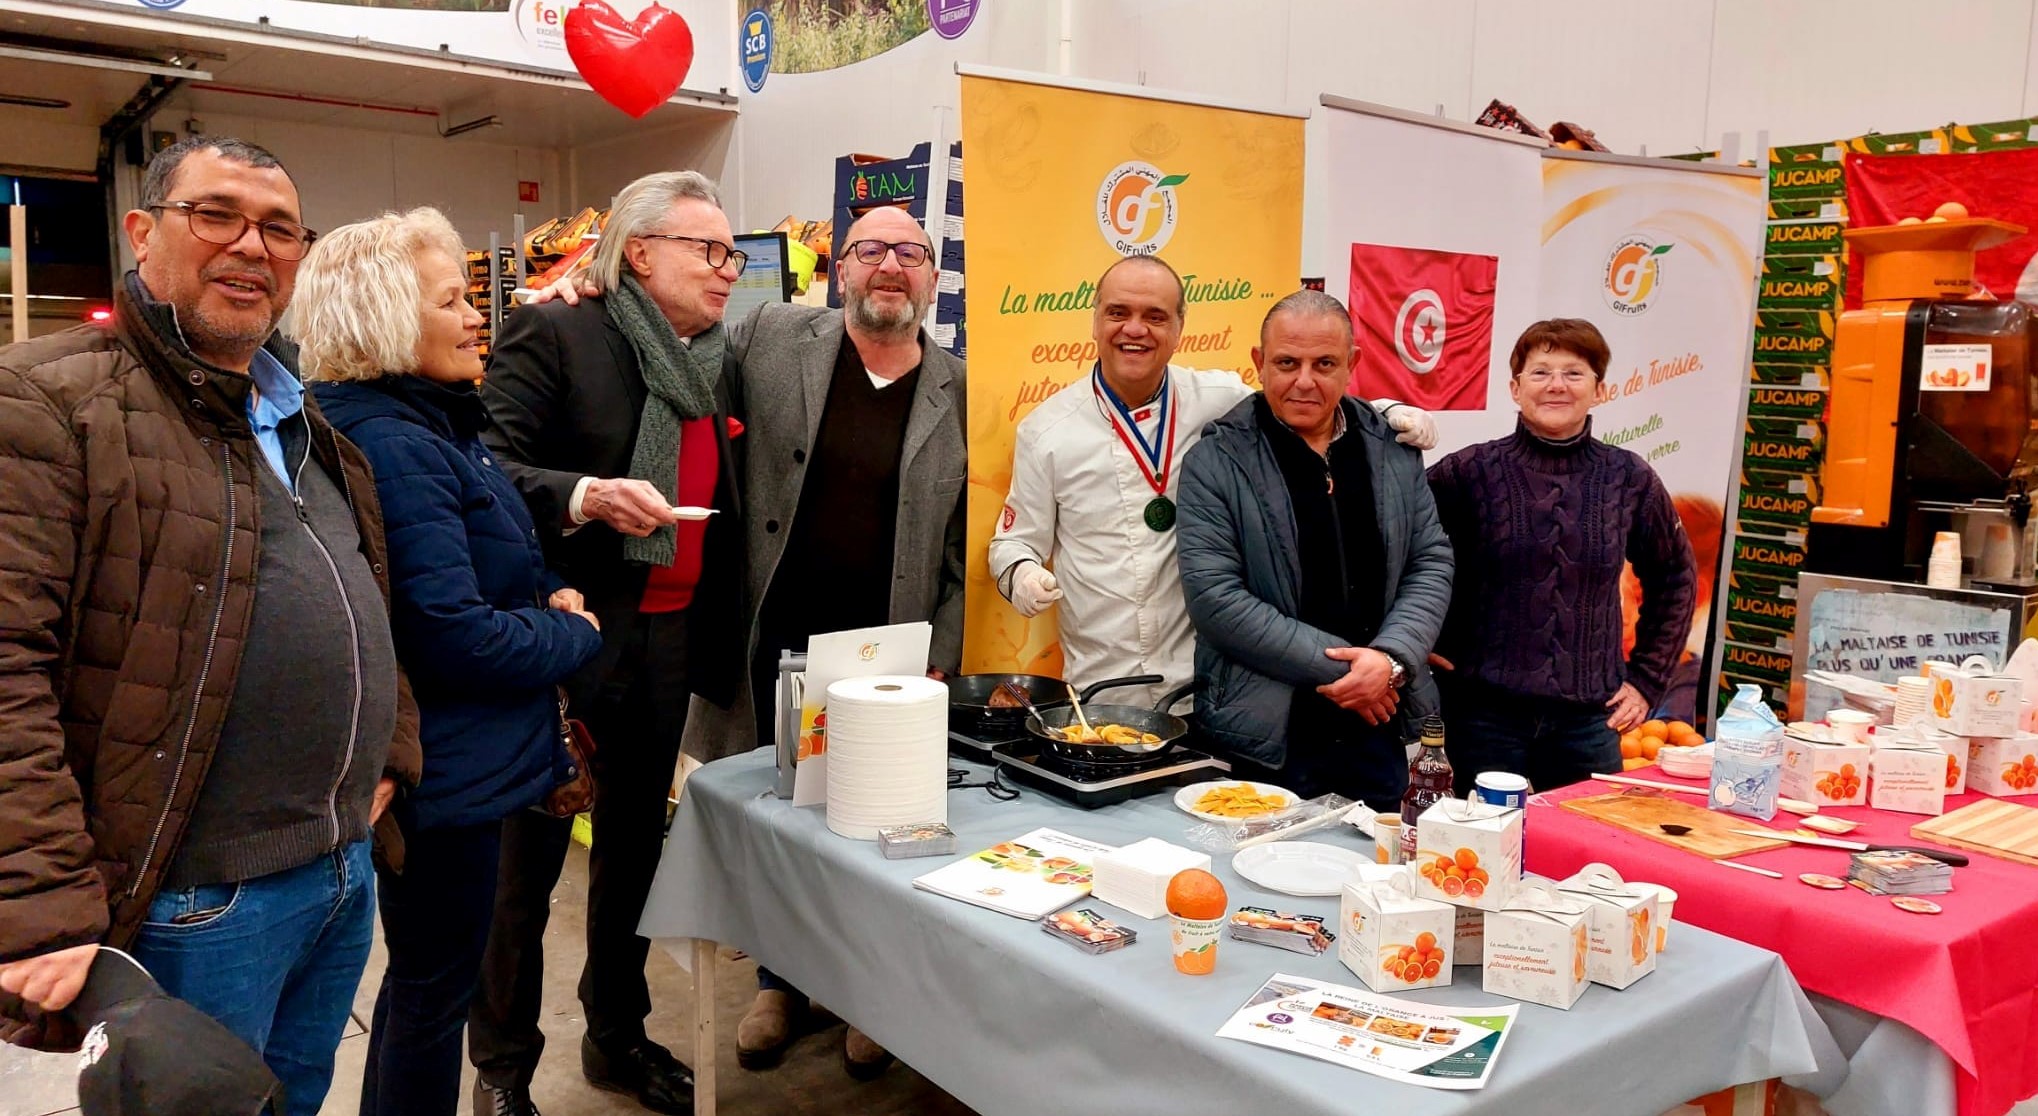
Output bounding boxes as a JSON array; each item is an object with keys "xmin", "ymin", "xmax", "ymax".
[{"xmin": 1176, "ymin": 399, "xmax": 1453, "ymax": 768}]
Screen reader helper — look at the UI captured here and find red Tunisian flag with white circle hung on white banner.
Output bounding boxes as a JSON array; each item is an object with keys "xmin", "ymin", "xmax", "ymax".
[{"xmin": 1347, "ymin": 244, "xmax": 1500, "ymax": 411}]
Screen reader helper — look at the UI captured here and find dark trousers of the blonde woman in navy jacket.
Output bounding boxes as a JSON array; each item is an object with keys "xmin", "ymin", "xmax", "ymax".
[{"xmin": 361, "ymin": 821, "xmax": 503, "ymax": 1116}]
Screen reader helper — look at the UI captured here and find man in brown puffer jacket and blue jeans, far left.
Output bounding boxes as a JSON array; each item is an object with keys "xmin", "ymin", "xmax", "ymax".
[{"xmin": 0, "ymin": 138, "xmax": 418, "ymax": 1112}]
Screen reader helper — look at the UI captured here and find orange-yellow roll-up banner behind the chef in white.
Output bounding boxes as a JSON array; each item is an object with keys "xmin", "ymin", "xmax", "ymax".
[{"xmin": 962, "ymin": 73, "xmax": 1302, "ymax": 674}]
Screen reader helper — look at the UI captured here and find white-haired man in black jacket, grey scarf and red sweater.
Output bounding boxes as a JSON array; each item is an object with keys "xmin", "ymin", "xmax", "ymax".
[{"xmin": 469, "ymin": 171, "xmax": 744, "ymax": 1114}]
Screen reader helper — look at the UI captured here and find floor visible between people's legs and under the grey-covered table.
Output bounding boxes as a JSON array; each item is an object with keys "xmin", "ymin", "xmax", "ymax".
[{"xmin": 0, "ymin": 845, "xmax": 970, "ymax": 1116}]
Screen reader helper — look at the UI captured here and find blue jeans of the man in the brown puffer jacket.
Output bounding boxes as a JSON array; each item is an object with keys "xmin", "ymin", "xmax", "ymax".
[{"xmin": 135, "ymin": 841, "xmax": 375, "ymax": 1114}]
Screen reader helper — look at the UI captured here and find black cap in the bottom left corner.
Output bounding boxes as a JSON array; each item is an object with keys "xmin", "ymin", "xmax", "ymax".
[{"xmin": 67, "ymin": 949, "xmax": 283, "ymax": 1116}]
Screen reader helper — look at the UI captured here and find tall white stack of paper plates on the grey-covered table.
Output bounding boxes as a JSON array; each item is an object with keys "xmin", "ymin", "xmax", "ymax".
[{"xmin": 827, "ymin": 674, "xmax": 948, "ymax": 841}]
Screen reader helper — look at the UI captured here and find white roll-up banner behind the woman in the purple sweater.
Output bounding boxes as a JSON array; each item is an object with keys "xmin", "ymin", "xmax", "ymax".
[{"xmin": 1540, "ymin": 153, "xmax": 1765, "ymax": 721}]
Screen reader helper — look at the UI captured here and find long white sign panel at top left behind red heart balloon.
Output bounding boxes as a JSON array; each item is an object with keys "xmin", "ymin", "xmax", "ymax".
[{"xmin": 113, "ymin": 0, "xmax": 736, "ymax": 92}]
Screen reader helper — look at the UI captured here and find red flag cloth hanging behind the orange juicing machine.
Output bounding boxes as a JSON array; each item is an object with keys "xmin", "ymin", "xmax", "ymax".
[{"xmin": 1846, "ymin": 147, "xmax": 2038, "ymax": 308}]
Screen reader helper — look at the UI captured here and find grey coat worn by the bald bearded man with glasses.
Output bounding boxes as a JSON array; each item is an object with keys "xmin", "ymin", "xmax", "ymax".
[{"xmin": 683, "ymin": 303, "xmax": 970, "ymax": 762}]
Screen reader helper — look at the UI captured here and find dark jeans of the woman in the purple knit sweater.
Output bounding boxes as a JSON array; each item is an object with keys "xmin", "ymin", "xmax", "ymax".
[{"xmin": 1441, "ymin": 674, "xmax": 1620, "ymax": 796}]
